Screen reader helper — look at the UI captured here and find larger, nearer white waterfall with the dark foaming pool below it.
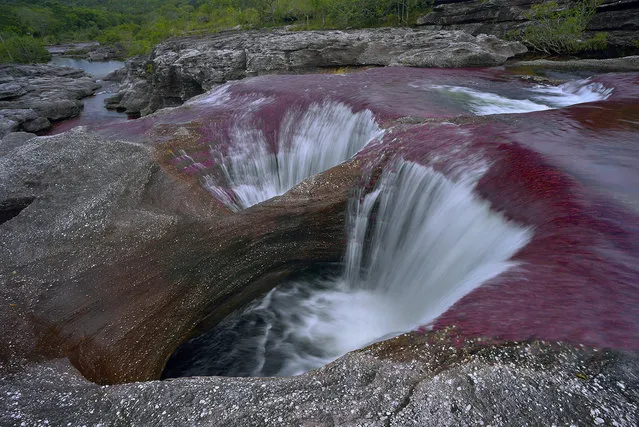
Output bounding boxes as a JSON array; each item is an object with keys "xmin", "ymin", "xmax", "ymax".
[{"xmin": 165, "ymin": 161, "xmax": 532, "ymax": 377}]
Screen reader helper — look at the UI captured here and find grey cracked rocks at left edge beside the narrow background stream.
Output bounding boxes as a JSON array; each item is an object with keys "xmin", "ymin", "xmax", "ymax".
[{"xmin": 0, "ymin": 65, "xmax": 100, "ymax": 138}]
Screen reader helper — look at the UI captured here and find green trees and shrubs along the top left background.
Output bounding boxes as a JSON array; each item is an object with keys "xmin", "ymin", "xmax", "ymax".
[{"xmin": 0, "ymin": 0, "xmax": 432, "ymax": 62}]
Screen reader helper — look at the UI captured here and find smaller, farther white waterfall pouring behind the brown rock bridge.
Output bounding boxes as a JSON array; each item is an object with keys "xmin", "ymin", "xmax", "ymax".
[{"xmin": 204, "ymin": 102, "xmax": 382, "ymax": 211}]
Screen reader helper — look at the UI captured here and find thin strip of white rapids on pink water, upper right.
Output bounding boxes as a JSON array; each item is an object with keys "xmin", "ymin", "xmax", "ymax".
[{"xmin": 418, "ymin": 79, "xmax": 612, "ymax": 116}]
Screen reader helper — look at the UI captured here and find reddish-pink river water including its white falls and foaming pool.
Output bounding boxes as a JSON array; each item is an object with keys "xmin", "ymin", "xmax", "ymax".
[{"xmin": 86, "ymin": 68, "xmax": 639, "ymax": 374}]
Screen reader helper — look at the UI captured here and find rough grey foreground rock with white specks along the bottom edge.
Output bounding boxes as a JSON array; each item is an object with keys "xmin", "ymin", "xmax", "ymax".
[{"xmin": 0, "ymin": 334, "xmax": 639, "ymax": 426}]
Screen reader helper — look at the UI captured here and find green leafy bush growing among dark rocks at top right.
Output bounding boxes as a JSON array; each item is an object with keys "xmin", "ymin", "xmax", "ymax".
[{"xmin": 518, "ymin": 0, "xmax": 607, "ymax": 54}]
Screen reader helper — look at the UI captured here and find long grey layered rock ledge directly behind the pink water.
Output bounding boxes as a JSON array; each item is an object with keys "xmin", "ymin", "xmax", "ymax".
[{"xmin": 107, "ymin": 28, "xmax": 526, "ymax": 115}]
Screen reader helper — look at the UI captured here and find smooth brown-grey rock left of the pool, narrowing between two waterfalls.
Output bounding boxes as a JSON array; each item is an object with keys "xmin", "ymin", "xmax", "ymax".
[{"xmin": 0, "ymin": 130, "xmax": 359, "ymax": 383}]
